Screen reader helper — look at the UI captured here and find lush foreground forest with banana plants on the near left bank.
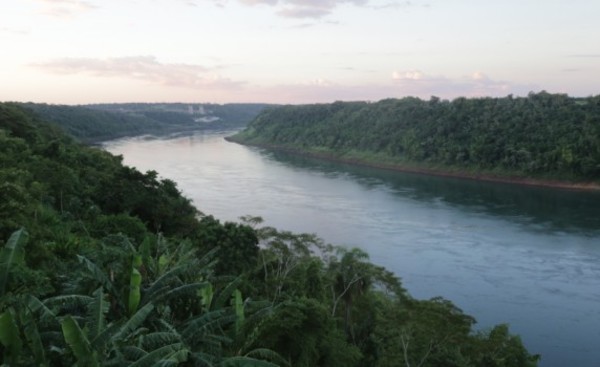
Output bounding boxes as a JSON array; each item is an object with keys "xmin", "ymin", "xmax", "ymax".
[{"xmin": 0, "ymin": 104, "xmax": 539, "ymax": 367}]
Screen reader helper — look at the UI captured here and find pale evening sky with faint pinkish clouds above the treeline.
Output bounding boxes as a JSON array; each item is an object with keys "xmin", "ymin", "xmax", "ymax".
[{"xmin": 0, "ymin": 0, "xmax": 600, "ymax": 104}]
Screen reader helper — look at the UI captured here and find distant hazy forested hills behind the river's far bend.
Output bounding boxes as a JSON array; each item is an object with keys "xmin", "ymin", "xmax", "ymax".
[{"xmin": 22, "ymin": 103, "xmax": 267, "ymax": 143}]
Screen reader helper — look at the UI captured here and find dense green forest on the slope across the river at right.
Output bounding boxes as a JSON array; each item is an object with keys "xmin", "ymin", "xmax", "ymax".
[{"xmin": 230, "ymin": 92, "xmax": 600, "ymax": 183}]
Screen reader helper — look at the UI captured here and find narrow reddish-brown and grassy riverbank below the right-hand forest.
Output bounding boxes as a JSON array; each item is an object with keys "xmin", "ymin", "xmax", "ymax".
[{"xmin": 225, "ymin": 136, "xmax": 600, "ymax": 191}]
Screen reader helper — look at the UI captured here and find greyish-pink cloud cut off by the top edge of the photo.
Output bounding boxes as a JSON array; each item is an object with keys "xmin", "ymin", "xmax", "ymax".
[{"xmin": 209, "ymin": 0, "xmax": 414, "ymax": 18}]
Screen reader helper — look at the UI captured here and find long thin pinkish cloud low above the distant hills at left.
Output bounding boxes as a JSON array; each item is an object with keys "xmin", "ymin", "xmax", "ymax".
[{"xmin": 32, "ymin": 56, "xmax": 242, "ymax": 89}]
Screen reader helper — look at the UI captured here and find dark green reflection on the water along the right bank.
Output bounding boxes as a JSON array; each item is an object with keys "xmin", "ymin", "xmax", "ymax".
[{"xmin": 263, "ymin": 151, "xmax": 600, "ymax": 236}]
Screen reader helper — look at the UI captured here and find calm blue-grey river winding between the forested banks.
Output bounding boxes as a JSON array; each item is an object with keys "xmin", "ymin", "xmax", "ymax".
[{"xmin": 105, "ymin": 133, "xmax": 600, "ymax": 367}]
